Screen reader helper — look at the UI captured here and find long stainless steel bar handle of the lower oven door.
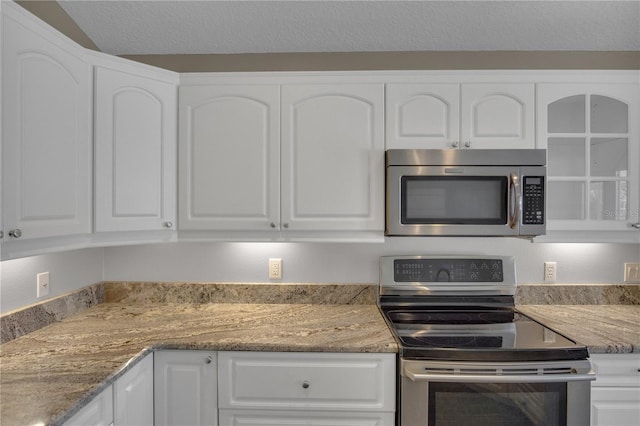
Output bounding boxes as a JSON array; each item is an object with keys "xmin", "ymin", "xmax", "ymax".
[{"xmin": 404, "ymin": 368, "xmax": 596, "ymax": 383}]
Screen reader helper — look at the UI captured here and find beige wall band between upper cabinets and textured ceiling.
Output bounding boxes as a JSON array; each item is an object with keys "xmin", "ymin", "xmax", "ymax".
[{"xmin": 17, "ymin": 0, "xmax": 640, "ymax": 72}]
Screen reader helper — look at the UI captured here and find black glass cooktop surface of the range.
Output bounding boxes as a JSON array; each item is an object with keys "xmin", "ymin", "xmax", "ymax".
[{"xmin": 383, "ymin": 307, "xmax": 588, "ymax": 361}]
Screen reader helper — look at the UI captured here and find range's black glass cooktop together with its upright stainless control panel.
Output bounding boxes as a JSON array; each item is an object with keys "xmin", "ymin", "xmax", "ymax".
[{"xmin": 379, "ymin": 256, "xmax": 588, "ymax": 361}]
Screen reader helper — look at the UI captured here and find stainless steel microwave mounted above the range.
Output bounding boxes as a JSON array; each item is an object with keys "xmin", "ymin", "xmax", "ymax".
[{"xmin": 385, "ymin": 149, "xmax": 546, "ymax": 237}]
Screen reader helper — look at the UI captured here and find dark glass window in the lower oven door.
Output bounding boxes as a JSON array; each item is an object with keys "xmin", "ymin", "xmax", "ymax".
[{"xmin": 428, "ymin": 382, "xmax": 567, "ymax": 426}]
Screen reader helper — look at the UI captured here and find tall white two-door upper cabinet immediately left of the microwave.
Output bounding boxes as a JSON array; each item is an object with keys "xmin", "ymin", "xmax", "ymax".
[{"xmin": 178, "ymin": 78, "xmax": 384, "ymax": 239}]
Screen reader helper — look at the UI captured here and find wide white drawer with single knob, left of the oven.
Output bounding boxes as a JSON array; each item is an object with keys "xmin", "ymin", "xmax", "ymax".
[{"xmin": 218, "ymin": 352, "xmax": 395, "ymax": 411}]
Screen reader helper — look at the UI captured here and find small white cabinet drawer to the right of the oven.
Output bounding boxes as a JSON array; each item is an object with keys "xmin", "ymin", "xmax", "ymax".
[{"xmin": 590, "ymin": 353, "xmax": 640, "ymax": 387}]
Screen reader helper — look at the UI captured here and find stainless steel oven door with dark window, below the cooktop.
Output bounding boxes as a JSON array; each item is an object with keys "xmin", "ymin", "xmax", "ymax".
[{"xmin": 400, "ymin": 360, "xmax": 595, "ymax": 426}]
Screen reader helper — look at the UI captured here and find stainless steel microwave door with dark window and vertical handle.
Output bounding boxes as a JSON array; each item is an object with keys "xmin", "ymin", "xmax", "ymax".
[{"xmin": 386, "ymin": 166, "xmax": 522, "ymax": 236}]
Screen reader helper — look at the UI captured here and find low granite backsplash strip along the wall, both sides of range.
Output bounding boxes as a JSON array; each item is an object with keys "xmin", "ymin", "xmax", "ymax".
[{"xmin": 0, "ymin": 282, "xmax": 640, "ymax": 343}]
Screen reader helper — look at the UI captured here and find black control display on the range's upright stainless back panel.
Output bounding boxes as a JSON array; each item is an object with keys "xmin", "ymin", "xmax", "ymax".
[{"xmin": 393, "ymin": 259, "xmax": 504, "ymax": 282}]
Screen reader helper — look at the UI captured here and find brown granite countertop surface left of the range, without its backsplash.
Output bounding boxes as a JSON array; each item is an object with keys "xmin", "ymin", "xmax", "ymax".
[{"xmin": 0, "ymin": 302, "xmax": 397, "ymax": 426}]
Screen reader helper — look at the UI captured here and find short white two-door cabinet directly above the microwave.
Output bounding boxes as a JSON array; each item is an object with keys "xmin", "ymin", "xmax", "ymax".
[{"xmin": 386, "ymin": 83, "xmax": 535, "ymax": 149}]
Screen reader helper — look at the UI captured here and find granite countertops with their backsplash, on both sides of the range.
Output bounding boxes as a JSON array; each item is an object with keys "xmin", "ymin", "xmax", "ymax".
[{"xmin": 0, "ymin": 283, "xmax": 640, "ymax": 426}]
